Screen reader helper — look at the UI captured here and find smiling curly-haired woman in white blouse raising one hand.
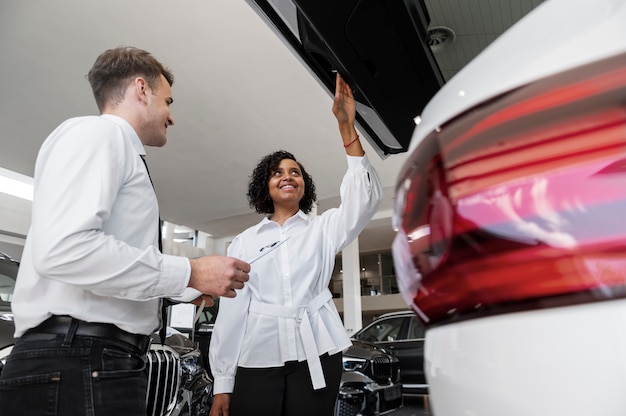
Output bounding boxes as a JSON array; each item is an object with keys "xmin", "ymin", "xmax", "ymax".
[{"xmin": 209, "ymin": 74, "xmax": 382, "ymax": 416}]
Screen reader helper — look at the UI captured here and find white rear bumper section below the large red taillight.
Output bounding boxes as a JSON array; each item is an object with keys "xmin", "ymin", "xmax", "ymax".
[{"xmin": 424, "ymin": 300, "xmax": 626, "ymax": 416}]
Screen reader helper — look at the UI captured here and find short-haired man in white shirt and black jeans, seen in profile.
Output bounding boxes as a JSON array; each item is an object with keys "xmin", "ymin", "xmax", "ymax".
[{"xmin": 0, "ymin": 47, "xmax": 250, "ymax": 416}]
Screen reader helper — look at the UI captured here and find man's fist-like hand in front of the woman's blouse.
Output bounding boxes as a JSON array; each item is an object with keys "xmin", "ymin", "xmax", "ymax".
[{"xmin": 189, "ymin": 256, "xmax": 250, "ymax": 304}]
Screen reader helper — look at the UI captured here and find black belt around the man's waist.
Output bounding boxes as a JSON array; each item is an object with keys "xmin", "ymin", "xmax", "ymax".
[{"xmin": 24, "ymin": 315, "xmax": 151, "ymax": 353}]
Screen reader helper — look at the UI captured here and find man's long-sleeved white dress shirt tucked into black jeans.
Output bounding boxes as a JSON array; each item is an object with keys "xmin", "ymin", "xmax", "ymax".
[{"xmin": 12, "ymin": 115, "xmax": 190, "ymax": 337}]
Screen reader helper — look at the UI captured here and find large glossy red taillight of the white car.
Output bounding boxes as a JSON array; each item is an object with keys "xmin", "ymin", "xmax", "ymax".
[{"xmin": 394, "ymin": 51, "xmax": 626, "ymax": 323}]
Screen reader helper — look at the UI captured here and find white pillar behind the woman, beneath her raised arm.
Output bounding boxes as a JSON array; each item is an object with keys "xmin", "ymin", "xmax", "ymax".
[{"xmin": 341, "ymin": 238, "xmax": 363, "ymax": 336}]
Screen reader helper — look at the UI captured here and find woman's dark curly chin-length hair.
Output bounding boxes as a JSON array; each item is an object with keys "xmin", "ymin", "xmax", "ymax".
[{"xmin": 247, "ymin": 150, "xmax": 317, "ymax": 214}]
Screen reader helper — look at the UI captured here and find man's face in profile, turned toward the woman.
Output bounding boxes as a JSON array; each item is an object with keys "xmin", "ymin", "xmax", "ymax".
[{"xmin": 141, "ymin": 75, "xmax": 174, "ymax": 147}]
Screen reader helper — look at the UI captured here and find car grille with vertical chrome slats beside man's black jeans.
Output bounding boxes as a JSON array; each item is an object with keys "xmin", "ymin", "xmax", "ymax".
[{"xmin": 146, "ymin": 344, "xmax": 180, "ymax": 416}]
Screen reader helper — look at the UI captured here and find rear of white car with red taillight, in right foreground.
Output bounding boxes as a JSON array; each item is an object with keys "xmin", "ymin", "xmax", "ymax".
[{"xmin": 393, "ymin": 0, "xmax": 626, "ymax": 416}]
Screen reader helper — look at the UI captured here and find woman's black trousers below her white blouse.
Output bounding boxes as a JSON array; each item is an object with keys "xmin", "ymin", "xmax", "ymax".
[{"xmin": 230, "ymin": 353, "xmax": 343, "ymax": 416}]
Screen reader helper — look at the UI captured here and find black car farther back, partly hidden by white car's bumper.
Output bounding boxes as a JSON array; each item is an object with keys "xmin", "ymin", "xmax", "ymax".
[{"xmin": 352, "ymin": 311, "xmax": 428, "ymax": 394}]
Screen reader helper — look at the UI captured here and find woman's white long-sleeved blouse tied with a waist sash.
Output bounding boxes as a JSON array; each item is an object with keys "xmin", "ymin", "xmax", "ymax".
[{"xmin": 209, "ymin": 156, "xmax": 382, "ymax": 393}]
